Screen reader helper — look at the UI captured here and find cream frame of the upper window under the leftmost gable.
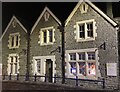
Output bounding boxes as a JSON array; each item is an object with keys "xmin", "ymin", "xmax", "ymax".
[{"xmin": 8, "ymin": 32, "xmax": 20, "ymax": 49}]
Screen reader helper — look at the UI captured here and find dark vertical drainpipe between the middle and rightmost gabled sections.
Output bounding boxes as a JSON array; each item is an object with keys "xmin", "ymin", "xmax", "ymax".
[{"xmin": 58, "ymin": 24, "xmax": 65, "ymax": 84}]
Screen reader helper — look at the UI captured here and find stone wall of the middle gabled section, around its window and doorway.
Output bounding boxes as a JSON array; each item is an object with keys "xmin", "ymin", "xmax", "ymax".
[{"xmin": 30, "ymin": 8, "xmax": 61, "ymax": 82}]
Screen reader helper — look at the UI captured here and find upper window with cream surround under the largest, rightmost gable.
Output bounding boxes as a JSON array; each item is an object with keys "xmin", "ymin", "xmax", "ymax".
[{"xmin": 76, "ymin": 19, "xmax": 96, "ymax": 42}]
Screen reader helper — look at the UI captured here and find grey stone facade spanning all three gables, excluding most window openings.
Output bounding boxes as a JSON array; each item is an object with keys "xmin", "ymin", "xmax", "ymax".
[{"xmin": 2, "ymin": 0, "xmax": 119, "ymax": 89}]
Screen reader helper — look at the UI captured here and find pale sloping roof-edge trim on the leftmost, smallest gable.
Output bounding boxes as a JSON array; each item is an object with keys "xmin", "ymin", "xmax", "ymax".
[{"xmin": 0, "ymin": 16, "xmax": 27, "ymax": 40}]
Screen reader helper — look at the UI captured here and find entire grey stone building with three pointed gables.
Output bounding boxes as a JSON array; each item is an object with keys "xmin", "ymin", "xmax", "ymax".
[{"xmin": 1, "ymin": 0, "xmax": 120, "ymax": 89}]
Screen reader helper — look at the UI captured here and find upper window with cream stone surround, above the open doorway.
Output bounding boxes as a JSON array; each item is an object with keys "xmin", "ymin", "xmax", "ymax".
[{"xmin": 38, "ymin": 27, "xmax": 55, "ymax": 45}]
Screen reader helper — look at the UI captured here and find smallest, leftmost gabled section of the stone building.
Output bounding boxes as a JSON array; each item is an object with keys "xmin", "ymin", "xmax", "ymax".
[{"xmin": 0, "ymin": 16, "xmax": 27, "ymax": 76}]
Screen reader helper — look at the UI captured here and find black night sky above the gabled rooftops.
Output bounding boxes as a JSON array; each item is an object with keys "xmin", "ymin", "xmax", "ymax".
[{"xmin": 2, "ymin": 2, "xmax": 120, "ymax": 30}]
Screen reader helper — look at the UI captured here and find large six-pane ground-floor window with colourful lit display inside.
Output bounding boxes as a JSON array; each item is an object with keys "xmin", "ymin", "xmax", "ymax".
[{"xmin": 66, "ymin": 48, "xmax": 98, "ymax": 78}]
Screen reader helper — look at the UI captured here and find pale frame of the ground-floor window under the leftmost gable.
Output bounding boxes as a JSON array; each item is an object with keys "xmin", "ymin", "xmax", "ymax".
[{"xmin": 7, "ymin": 54, "xmax": 20, "ymax": 75}]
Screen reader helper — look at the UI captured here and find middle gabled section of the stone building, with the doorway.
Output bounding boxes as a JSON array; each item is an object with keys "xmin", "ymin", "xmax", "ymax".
[{"xmin": 30, "ymin": 7, "xmax": 61, "ymax": 82}]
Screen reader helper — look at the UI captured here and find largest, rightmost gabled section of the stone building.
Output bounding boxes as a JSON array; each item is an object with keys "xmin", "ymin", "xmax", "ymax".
[{"xmin": 65, "ymin": 1, "xmax": 119, "ymax": 89}]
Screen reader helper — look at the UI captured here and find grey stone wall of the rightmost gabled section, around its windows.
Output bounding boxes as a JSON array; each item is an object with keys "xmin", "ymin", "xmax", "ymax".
[{"xmin": 65, "ymin": 1, "xmax": 119, "ymax": 89}]
